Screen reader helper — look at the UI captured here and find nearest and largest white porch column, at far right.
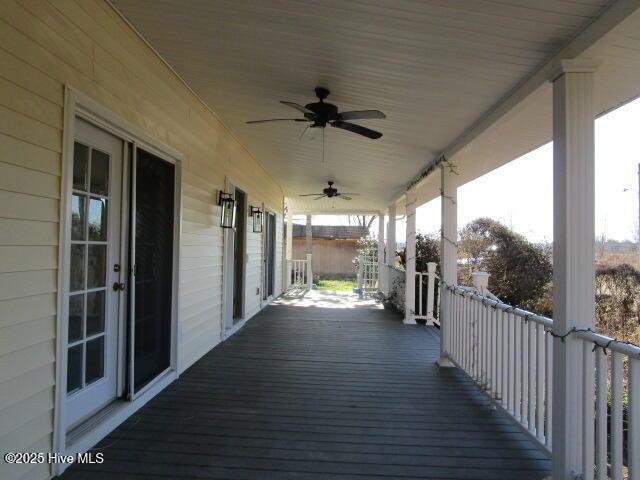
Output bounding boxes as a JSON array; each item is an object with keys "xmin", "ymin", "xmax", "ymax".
[{"xmin": 552, "ymin": 61, "xmax": 595, "ymax": 480}]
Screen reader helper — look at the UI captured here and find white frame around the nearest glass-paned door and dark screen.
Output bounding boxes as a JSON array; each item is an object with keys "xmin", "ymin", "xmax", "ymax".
[{"xmin": 53, "ymin": 85, "xmax": 183, "ymax": 475}]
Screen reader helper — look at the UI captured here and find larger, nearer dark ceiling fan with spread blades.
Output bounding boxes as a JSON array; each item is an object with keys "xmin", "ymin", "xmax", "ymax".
[{"xmin": 247, "ymin": 87, "xmax": 386, "ymax": 140}]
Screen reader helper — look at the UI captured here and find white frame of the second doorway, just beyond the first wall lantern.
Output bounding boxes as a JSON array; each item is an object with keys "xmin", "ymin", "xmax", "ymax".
[{"xmin": 220, "ymin": 176, "xmax": 249, "ymax": 341}]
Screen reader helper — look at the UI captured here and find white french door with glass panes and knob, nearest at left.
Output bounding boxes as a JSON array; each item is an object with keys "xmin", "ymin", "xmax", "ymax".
[{"xmin": 65, "ymin": 118, "xmax": 125, "ymax": 429}]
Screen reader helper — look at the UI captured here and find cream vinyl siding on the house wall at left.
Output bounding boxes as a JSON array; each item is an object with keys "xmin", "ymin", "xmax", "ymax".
[{"xmin": 0, "ymin": 0, "xmax": 282, "ymax": 479}]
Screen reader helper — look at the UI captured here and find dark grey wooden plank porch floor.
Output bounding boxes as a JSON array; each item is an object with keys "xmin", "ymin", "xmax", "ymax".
[{"xmin": 62, "ymin": 292, "xmax": 550, "ymax": 480}]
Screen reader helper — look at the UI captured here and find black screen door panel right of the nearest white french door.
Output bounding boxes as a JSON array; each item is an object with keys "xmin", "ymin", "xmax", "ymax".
[{"xmin": 132, "ymin": 149, "xmax": 175, "ymax": 392}]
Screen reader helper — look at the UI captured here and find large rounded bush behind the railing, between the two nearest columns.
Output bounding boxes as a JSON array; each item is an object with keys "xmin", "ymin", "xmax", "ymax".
[{"xmin": 458, "ymin": 218, "xmax": 553, "ymax": 314}]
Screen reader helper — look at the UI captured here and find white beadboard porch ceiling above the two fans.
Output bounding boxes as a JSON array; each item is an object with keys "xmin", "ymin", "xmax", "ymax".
[{"xmin": 112, "ymin": 0, "xmax": 609, "ymax": 213}]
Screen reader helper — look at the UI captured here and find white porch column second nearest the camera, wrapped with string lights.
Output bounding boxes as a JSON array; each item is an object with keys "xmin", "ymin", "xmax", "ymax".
[{"xmin": 437, "ymin": 163, "xmax": 458, "ymax": 367}]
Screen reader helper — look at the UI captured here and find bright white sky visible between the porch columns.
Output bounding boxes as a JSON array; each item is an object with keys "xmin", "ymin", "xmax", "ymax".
[{"xmin": 294, "ymin": 99, "xmax": 640, "ymax": 242}]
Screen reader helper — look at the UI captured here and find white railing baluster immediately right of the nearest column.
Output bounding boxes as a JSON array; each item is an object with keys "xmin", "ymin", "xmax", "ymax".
[{"xmin": 582, "ymin": 342, "xmax": 595, "ymax": 480}]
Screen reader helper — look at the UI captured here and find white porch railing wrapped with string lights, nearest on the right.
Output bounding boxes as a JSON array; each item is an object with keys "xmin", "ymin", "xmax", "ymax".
[{"xmin": 442, "ymin": 282, "xmax": 640, "ymax": 480}]
